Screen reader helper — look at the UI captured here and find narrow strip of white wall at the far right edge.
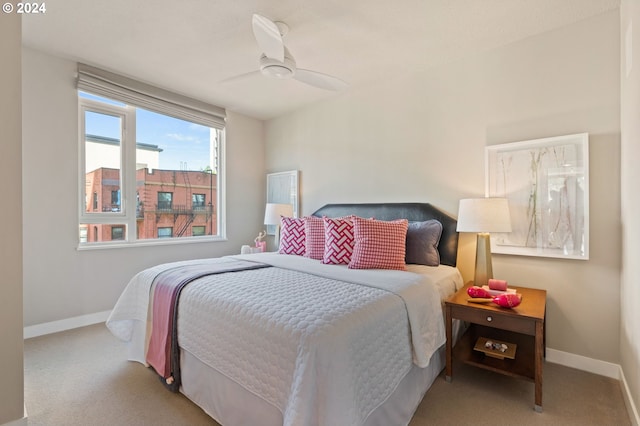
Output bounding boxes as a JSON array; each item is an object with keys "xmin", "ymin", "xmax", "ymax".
[{"xmin": 620, "ymin": 0, "xmax": 640, "ymax": 419}]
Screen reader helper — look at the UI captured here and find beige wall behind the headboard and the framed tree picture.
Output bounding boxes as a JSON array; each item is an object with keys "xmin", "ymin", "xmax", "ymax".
[{"xmin": 265, "ymin": 11, "xmax": 620, "ymax": 363}]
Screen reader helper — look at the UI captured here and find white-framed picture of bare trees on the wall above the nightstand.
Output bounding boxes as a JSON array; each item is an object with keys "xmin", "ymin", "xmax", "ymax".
[{"xmin": 485, "ymin": 133, "xmax": 589, "ymax": 260}]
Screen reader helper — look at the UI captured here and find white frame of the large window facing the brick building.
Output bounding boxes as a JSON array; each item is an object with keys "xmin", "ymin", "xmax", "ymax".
[{"xmin": 77, "ymin": 68, "xmax": 227, "ymax": 250}]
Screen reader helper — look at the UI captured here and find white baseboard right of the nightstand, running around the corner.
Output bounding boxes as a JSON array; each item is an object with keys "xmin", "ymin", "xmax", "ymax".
[{"xmin": 546, "ymin": 348, "xmax": 640, "ymax": 426}]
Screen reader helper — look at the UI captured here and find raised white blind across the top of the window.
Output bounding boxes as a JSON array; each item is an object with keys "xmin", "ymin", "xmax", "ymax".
[{"xmin": 78, "ymin": 63, "xmax": 226, "ymax": 129}]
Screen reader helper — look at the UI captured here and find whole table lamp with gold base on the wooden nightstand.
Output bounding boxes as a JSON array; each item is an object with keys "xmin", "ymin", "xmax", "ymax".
[{"xmin": 456, "ymin": 198, "xmax": 511, "ymax": 286}]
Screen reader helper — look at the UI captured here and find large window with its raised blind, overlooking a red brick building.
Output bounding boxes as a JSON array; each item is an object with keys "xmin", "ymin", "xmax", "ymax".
[{"xmin": 78, "ymin": 64, "xmax": 225, "ymax": 246}]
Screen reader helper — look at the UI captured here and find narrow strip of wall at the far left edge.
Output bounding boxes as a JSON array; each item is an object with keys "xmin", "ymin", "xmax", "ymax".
[{"xmin": 0, "ymin": 14, "xmax": 25, "ymax": 425}]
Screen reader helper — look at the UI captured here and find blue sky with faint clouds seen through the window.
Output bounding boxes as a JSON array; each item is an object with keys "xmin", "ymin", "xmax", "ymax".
[{"xmin": 81, "ymin": 93, "xmax": 211, "ymax": 170}]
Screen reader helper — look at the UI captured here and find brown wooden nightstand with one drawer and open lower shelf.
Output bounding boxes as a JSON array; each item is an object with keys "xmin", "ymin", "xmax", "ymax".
[{"xmin": 445, "ymin": 283, "xmax": 547, "ymax": 412}]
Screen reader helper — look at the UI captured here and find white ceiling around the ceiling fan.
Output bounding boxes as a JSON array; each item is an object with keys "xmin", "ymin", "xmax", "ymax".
[{"xmin": 22, "ymin": 0, "xmax": 620, "ymax": 119}]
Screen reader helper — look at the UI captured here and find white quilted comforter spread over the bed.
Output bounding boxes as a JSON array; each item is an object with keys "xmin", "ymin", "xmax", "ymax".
[{"xmin": 107, "ymin": 253, "xmax": 461, "ymax": 425}]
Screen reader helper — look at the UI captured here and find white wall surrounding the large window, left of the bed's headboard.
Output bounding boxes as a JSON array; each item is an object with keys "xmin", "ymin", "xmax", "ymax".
[{"xmin": 22, "ymin": 48, "xmax": 265, "ymax": 326}]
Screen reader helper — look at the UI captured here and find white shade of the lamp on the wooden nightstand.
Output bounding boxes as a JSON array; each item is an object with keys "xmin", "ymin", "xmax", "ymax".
[{"xmin": 456, "ymin": 198, "xmax": 511, "ymax": 232}]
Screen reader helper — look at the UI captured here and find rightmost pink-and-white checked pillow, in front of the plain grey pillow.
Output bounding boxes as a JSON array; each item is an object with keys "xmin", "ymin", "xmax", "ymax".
[{"xmin": 349, "ymin": 217, "xmax": 409, "ymax": 270}]
